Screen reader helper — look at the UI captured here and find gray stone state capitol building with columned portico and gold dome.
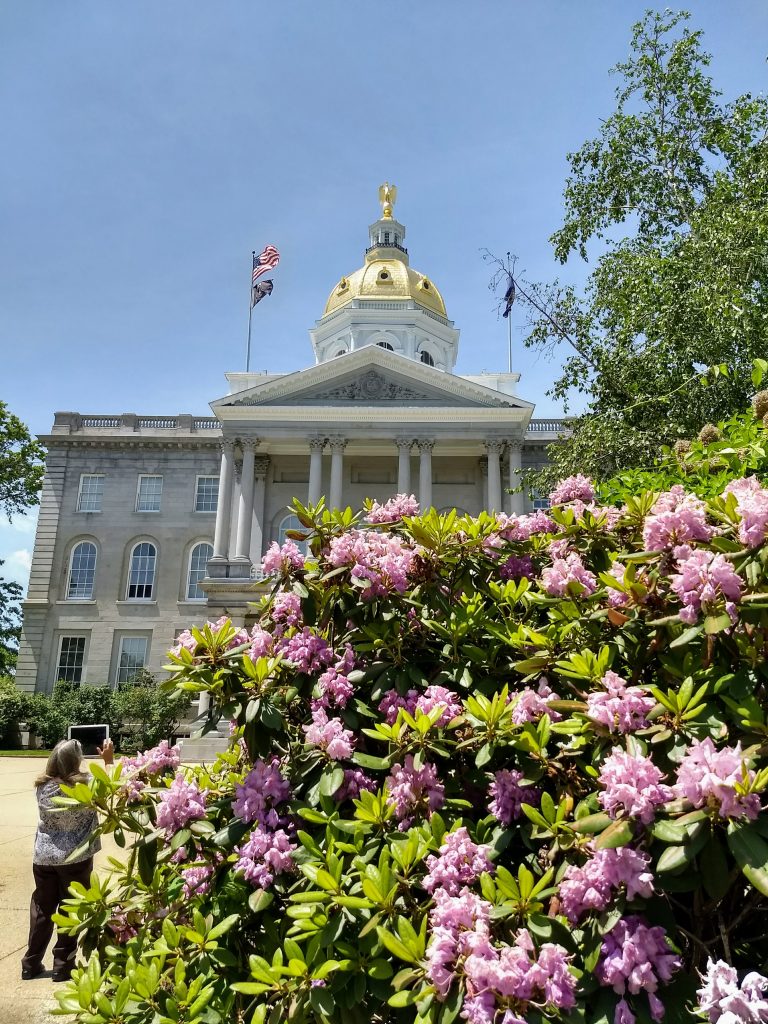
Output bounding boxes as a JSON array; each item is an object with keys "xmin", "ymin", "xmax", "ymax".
[{"xmin": 16, "ymin": 189, "xmax": 563, "ymax": 691}]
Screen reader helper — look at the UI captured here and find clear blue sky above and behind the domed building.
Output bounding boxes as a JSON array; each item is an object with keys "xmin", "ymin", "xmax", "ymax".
[{"xmin": 0, "ymin": 0, "xmax": 768, "ymax": 582}]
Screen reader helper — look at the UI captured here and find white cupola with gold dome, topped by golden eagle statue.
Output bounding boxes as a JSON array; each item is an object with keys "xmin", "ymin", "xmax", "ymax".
[{"xmin": 309, "ymin": 182, "xmax": 459, "ymax": 372}]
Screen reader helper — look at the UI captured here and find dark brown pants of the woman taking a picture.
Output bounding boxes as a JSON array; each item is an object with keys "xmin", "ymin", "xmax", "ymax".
[{"xmin": 22, "ymin": 857, "xmax": 93, "ymax": 971}]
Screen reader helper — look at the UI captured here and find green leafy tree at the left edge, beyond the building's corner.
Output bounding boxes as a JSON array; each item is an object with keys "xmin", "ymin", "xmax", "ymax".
[{"xmin": 0, "ymin": 401, "xmax": 44, "ymax": 674}]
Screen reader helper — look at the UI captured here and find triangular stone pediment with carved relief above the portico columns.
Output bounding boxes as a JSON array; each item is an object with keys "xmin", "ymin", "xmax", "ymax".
[{"xmin": 214, "ymin": 346, "xmax": 529, "ymax": 410}]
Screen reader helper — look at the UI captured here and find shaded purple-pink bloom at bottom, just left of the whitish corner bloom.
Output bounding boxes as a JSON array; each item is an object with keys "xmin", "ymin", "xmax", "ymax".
[{"xmin": 595, "ymin": 915, "xmax": 680, "ymax": 1021}]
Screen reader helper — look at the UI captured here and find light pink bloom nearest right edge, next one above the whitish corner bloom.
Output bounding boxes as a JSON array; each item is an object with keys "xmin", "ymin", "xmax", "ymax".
[{"xmin": 674, "ymin": 736, "xmax": 760, "ymax": 820}]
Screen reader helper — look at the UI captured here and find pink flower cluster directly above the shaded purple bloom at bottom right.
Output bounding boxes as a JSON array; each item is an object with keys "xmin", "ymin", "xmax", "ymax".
[{"xmin": 560, "ymin": 846, "xmax": 653, "ymax": 925}]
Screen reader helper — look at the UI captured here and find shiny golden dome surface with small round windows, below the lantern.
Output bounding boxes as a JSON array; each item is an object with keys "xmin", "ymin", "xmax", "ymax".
[{"xmin": 323, "ymin": 254, "xmax": 446, "ymax": 316}]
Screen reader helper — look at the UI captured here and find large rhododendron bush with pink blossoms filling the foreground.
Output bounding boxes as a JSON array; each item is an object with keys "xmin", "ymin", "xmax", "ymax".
[{"xmin": 51, "ymin": 477, "xmax": 768, "ymax": 1024}]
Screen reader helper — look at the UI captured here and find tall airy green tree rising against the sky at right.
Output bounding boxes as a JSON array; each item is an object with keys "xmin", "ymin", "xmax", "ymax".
[{"xmin": 517, "ymin": 11, "xmax": 768, "ymax": 486}]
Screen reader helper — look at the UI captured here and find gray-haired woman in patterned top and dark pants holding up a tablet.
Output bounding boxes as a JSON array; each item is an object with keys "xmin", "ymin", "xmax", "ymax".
[{"xmin": 22, "ymin": 739, "xmax": 115, "ymax": 981}]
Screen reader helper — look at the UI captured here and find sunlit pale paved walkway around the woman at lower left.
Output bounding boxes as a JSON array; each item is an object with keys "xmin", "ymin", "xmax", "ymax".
[{"xmin": 0, "ymin": 758, "xmax": 118, "ymax": 1024}]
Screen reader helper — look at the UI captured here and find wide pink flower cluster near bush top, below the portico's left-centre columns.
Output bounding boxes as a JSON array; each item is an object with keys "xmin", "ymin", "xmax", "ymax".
[{"xmin": 327, "ymin": 529, "xmax": 416, "ymax": 600}]
